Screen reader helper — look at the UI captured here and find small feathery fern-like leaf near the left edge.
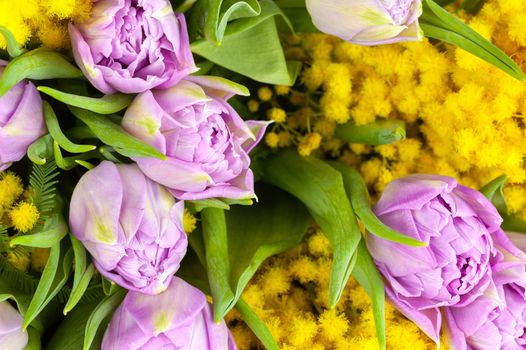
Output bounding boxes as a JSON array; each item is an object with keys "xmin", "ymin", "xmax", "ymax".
[{"xmin": 29, "ymin": 161, "xmax": 59, "ymax": 219}]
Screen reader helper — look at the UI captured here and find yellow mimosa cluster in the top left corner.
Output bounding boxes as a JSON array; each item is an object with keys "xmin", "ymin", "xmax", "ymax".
[{"xmin": 0, "ymin": 0, "xmax": 92, "ymax": 50}]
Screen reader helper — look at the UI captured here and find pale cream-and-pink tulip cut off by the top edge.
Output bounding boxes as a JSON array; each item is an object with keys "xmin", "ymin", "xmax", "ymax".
[{"xmin": 306, "ymin": 0, "xmax": 423, "ymax": 45}]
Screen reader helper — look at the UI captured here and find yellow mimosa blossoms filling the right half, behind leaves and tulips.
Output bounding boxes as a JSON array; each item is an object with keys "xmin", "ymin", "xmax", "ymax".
[{"xmin": 238, "ymin": 0, "xmax": 526, "ymax": 349}]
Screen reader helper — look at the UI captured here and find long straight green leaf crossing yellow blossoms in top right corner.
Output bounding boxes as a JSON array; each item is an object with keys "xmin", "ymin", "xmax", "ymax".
[{"xmin": 419, "ymin": 0, "xmax": 526, "ymax": 81}]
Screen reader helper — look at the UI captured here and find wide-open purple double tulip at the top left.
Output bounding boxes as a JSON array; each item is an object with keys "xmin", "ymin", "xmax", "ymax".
[{"xmin": 69, "ymin": 0, "xmax": 197, "ymax": 94}]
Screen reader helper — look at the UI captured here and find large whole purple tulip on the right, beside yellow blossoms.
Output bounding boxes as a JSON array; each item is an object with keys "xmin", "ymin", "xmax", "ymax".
[{"xmin": 367, "ymin": 175, "xmax": 502, "ymax": 343}]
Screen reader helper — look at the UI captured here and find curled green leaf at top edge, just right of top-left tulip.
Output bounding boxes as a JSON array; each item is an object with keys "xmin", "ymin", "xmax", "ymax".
[{"xmin": 189, "ymin": 0, "xmax": 261, "ymax": 46}]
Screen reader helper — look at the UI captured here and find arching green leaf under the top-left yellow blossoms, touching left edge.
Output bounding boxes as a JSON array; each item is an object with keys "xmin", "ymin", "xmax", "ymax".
[{"xmin": 0, "ymin": 48, "xmax": 83, "ymax": 96}]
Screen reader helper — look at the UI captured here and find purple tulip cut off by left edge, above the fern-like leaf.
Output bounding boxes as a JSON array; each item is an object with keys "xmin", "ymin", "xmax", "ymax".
[{"xmin": 0, "ymin": 60, "xmax": 46, "ymax": 171}]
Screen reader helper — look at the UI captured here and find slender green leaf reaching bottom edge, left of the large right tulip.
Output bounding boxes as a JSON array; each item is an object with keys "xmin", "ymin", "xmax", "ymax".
[{"xmin": 352, "ymin": 240, "xmax": 386, "ymax": 350}]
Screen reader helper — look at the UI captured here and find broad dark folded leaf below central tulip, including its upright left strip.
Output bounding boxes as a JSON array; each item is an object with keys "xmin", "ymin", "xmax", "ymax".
[{"xmin": 200, "ymin": 184, "xmax": 310, "ymax": 320}]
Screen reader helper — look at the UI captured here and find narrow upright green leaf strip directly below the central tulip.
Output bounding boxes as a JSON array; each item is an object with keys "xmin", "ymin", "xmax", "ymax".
[{"xmin": 201, "ymin": 208, "xmax": 234, "ymax": 322}]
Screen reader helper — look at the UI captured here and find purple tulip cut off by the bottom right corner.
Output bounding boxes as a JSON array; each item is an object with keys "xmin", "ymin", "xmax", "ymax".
[{"xmin": 446, "ymin": 231, "xmax": 526, "ymax": 350}]
